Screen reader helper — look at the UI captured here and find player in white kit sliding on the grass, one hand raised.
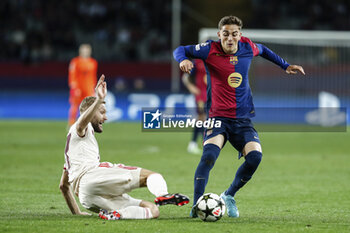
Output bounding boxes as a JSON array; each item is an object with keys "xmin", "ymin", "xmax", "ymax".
[{"xmin": 60, "ymin": 75, "xmax": 189, "ymax": 220}]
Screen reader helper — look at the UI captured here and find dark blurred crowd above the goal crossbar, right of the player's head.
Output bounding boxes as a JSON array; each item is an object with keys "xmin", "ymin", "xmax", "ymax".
[{"xmin": 249, "ymin": 0, "xmax": 350, "ymax": 31}]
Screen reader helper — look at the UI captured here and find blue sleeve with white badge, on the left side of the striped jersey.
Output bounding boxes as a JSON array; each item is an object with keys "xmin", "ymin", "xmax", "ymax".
[{"xmin": 173, "ymin": 41, "xmax": 211, "ymax": 63}]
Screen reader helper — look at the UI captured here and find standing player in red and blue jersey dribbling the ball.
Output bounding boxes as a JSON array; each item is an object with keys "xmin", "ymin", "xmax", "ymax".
[{"xmin": 174, "ymin": 16, "xmax": 305, "ymax": 217}]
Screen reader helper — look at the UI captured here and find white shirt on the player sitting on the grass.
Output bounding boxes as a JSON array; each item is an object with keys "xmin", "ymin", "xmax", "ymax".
[{"xmin": 64, "ymin": 123, "xmax": 100, "ymax": 193}]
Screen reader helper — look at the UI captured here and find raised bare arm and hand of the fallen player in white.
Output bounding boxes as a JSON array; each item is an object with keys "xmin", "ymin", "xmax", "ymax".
[{"xmin": 77, "ymin": 75, "xmax": 107, "ymax": 137}]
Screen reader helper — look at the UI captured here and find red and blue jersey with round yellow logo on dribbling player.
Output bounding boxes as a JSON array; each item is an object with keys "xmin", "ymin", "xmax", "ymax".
[{"xmin": 173, "ymin": 36, "xmax": 289, "ymax": 118}]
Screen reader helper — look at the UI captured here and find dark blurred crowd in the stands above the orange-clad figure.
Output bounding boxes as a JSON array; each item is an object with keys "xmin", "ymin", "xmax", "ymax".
[{"xmin": 0, "ymin": 0, "xmax": 171, "ymax": 62}]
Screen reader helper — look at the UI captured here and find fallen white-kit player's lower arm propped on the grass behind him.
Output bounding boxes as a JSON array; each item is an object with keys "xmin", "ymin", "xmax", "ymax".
[{"xmin": 60, "ymin": 170, "xmax": 91, "ymax": 215}]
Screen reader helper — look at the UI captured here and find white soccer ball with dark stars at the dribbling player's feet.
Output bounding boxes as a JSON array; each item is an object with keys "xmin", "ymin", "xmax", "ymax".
[{"xmin": 196, "ymin": 193, "xmax": 226, "ymax": 222}]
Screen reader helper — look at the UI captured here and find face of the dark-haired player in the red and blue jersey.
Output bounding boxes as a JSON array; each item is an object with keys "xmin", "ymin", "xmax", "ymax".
[{"xmin": 218, "ymin": 24, "xmax": 242, "ymax": 54}]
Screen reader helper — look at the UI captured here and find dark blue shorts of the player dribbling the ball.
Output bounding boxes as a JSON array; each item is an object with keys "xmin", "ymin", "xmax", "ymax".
[{"xmin": 204, "ymin": 117, "xmax": 260, "ymax": 158}]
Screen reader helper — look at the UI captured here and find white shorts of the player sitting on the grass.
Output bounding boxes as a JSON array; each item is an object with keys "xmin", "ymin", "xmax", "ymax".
[{"xmin": 79, "ymin": 162, "xmax": 142, "ymax": 212}]
